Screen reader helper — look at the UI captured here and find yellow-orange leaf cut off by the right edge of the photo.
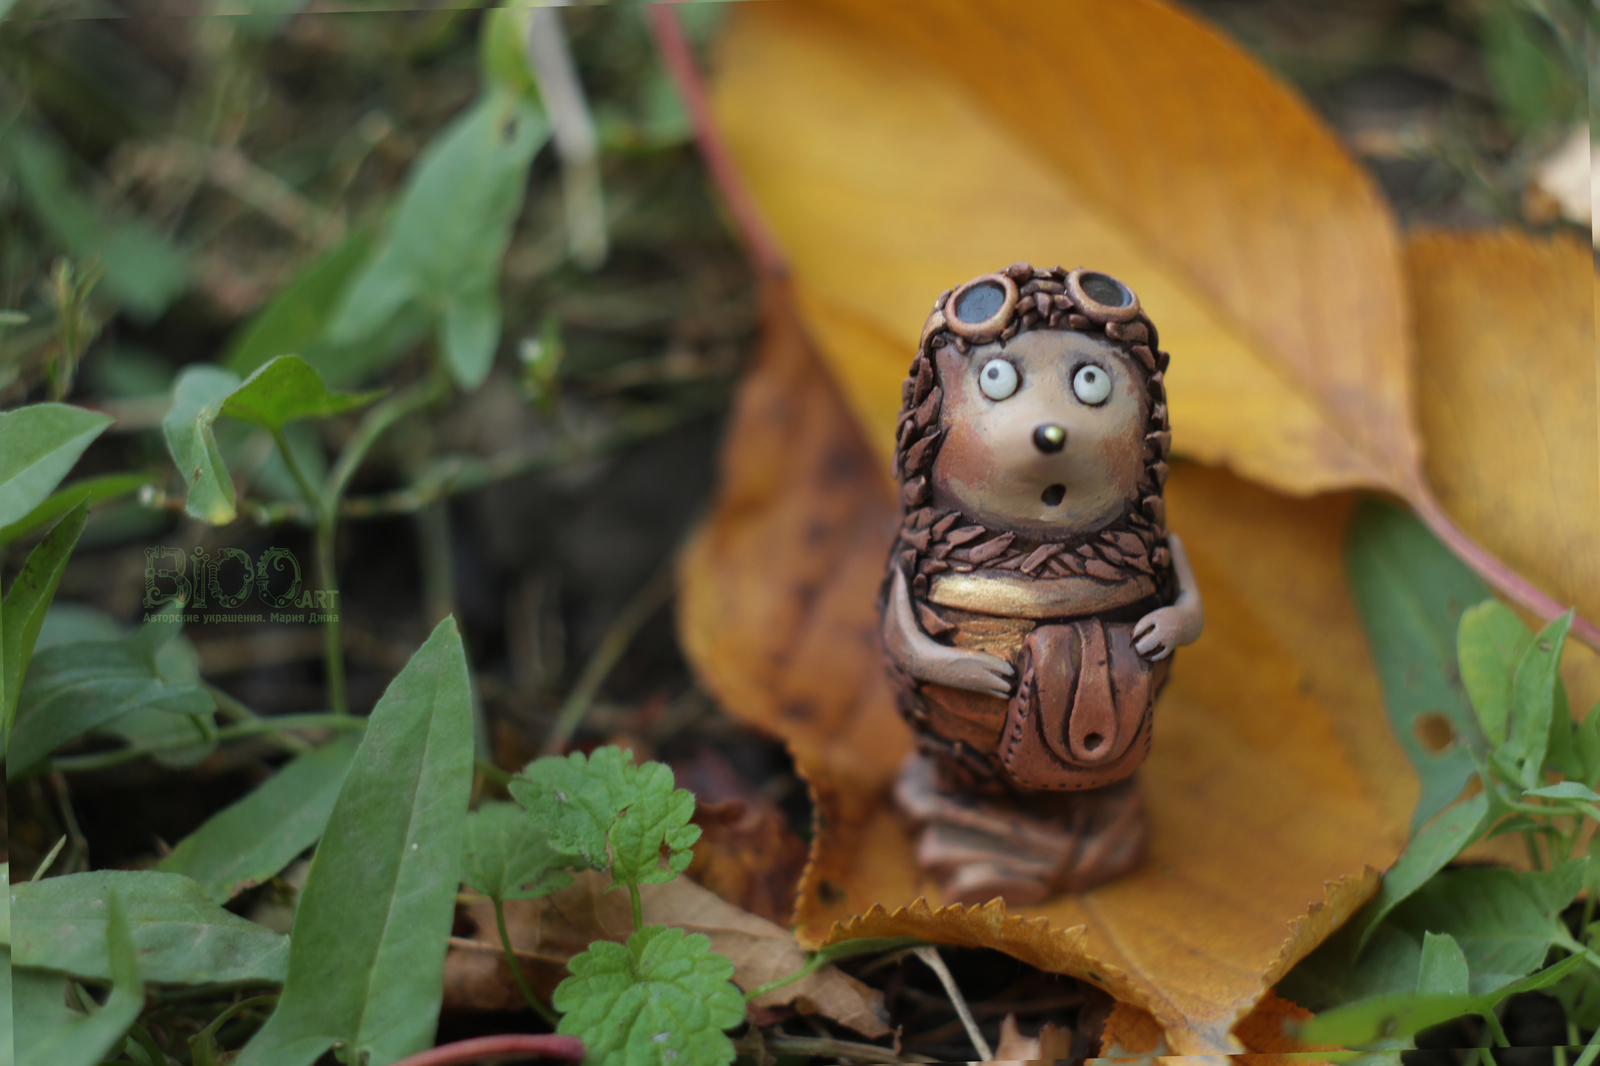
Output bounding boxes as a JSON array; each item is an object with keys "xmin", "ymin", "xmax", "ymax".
[{"xmin": 1414, "ymin": 232, "xmax": 1600, "ymax": 712}]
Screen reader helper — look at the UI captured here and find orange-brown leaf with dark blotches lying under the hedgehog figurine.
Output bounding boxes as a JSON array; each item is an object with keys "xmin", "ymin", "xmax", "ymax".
[{"xmin": 680, "ymin": 295, "xmax": 1416, "ymax": 1053}]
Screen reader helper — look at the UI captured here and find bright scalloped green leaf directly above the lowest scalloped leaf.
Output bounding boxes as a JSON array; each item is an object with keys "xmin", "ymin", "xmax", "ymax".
[{"xmin": 509, "ymin": 746, "xmax": 701, "ymax": 885}]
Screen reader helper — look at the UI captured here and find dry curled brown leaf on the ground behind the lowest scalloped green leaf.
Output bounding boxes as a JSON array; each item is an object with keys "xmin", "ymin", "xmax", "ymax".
[{"xmin": 445, "ymin": 872, "xmax": 890, "ymax": 1039}]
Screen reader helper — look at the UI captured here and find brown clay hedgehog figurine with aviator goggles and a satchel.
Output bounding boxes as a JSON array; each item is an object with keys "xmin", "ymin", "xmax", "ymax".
[{"xmin": 882, "ymin": 262, "xmax": 1202, "ymax": 904}]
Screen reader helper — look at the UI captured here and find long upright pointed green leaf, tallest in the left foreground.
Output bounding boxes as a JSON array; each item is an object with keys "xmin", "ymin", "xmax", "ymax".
[{"xmin": 235, "ymin": 618, "xmax": 472, "ymax": 1066}]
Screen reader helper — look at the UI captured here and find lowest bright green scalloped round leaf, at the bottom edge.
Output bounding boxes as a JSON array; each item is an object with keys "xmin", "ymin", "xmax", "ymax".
[{"xmin": 552, "ymin": 925, "xmax": 744, "ymax": 1066}]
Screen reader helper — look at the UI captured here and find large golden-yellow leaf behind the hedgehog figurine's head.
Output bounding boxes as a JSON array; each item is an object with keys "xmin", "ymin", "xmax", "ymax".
[{"xmin": 715, "ymin": 0, "xmax": 1418, "ymax": 496}]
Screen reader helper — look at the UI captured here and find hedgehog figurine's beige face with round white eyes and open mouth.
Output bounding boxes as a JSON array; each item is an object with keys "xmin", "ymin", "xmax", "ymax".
[{"xmin": 933, "ymin": 330, "xmax": 1149, "ymax": 539}]
